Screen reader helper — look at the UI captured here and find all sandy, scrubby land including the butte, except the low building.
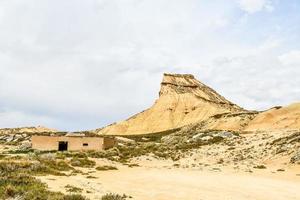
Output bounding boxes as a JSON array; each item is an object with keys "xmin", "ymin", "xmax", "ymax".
[{"xmin": 0, "ymin": 74, "xmax": 300, "ymax": 200}]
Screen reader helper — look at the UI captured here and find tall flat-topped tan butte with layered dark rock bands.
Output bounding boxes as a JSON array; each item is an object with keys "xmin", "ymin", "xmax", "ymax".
[{"xmin": 95, "ymin": 74, "xmax": 245, "ymax": 135}]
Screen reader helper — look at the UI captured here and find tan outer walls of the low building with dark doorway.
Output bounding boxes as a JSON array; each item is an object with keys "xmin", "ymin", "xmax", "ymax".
[{"xmin": 31, "ymin": 135, "xmax": 115, "ymax": 151}]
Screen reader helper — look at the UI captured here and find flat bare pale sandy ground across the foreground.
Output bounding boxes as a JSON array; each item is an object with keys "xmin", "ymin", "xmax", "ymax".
[{"xmin": 39, "ymin": 164, "xmax": 300, "ymax": 200}]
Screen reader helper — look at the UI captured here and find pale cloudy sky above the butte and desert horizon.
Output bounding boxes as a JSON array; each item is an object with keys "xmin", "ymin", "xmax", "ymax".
[{"xmin": 0, "ymin": 0, "xmax": 300, "ymax": 131}]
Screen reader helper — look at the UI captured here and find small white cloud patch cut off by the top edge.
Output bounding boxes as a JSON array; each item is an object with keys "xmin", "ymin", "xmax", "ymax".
[{"xmin": 238, "ymin": 0, "xmax": 274, "ymax": 14}]
